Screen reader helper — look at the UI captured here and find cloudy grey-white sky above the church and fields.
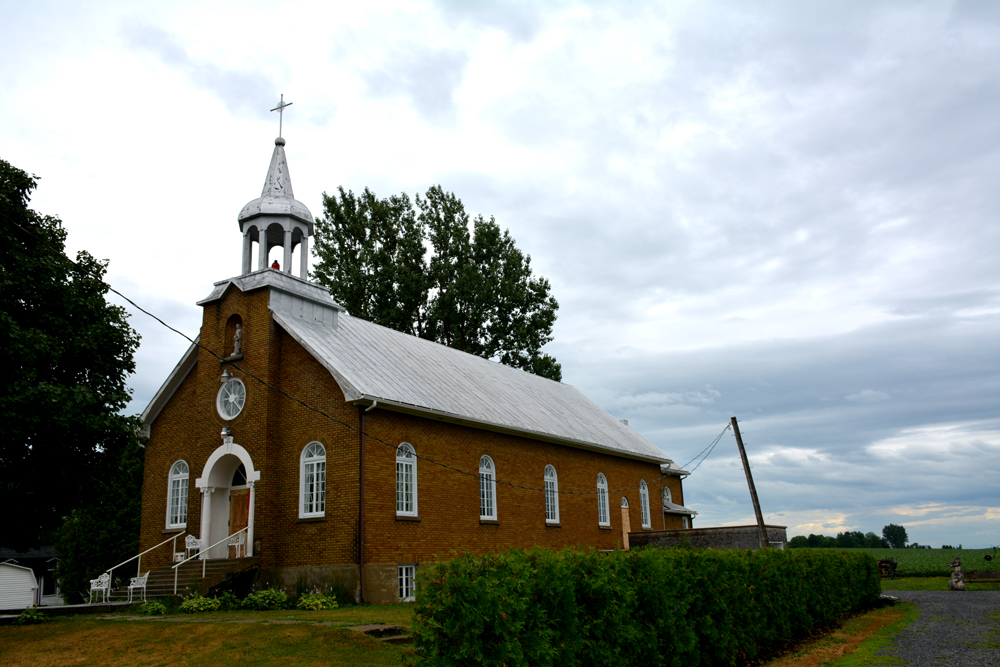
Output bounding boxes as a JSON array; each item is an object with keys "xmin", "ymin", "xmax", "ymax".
[{"xmin": 0, "ymin": 0, "xmax": 1000, "ymax": 547}]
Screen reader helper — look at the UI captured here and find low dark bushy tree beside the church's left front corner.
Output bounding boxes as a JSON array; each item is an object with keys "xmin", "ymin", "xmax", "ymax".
[{"xmin": 55, "ymin": 438, "xmax": 145, "ymax": 604}]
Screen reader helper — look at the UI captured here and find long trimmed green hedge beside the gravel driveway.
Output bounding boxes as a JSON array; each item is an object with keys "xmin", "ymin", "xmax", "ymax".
[{"xmin": 413, "ymin": 548, "xmax": 881, "ymax": 667}]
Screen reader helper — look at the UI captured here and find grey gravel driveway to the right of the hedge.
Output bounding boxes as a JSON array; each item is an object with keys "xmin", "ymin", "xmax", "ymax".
[{"xmin": 878, "ymin": 591, "xmax": 1000, "ymax": 667}]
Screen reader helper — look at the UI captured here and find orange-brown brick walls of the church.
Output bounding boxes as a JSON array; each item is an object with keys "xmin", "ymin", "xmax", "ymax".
[{"xmin": 141, "ymin": 288, "xmax": 683, "ymax": 598}]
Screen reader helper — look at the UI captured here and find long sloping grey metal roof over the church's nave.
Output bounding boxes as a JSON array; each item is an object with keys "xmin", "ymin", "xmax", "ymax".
[{"xmin": 271, "ymin": 306, "xmax": 671, "ymax": 463}]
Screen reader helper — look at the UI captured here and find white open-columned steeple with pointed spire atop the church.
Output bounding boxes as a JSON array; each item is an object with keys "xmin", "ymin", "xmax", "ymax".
[{"xmin": 239, "ymin": 137, "xmax": 313, "ymax": 280}]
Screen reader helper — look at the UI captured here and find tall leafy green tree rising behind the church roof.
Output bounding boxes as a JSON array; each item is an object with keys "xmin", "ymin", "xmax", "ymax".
[{"xmin": 313, "ymin": 185, "xmax": 562, "ymax": 381}]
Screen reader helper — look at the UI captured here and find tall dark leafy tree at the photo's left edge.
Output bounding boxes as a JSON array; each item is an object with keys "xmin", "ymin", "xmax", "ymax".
[{"xmin": 0, "ymin": 160, "xmax": 139, "ymax": 550}]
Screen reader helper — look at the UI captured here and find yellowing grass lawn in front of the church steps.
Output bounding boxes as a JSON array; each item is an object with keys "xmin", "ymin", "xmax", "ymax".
[{"xmin": 0, "ymin": 605, "xmax": 413, "ymax": 667}]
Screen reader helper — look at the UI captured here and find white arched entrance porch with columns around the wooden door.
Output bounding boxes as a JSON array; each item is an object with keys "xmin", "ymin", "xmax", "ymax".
[{"xmin": 195, "ymin": 435, "xmax": 260, "ymax": 559}]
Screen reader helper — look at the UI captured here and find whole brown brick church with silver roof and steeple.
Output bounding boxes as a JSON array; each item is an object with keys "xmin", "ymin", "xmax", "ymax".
[{"xmin": 141, "ymin": 133, "xmax": 694, "ymax": 602}]
